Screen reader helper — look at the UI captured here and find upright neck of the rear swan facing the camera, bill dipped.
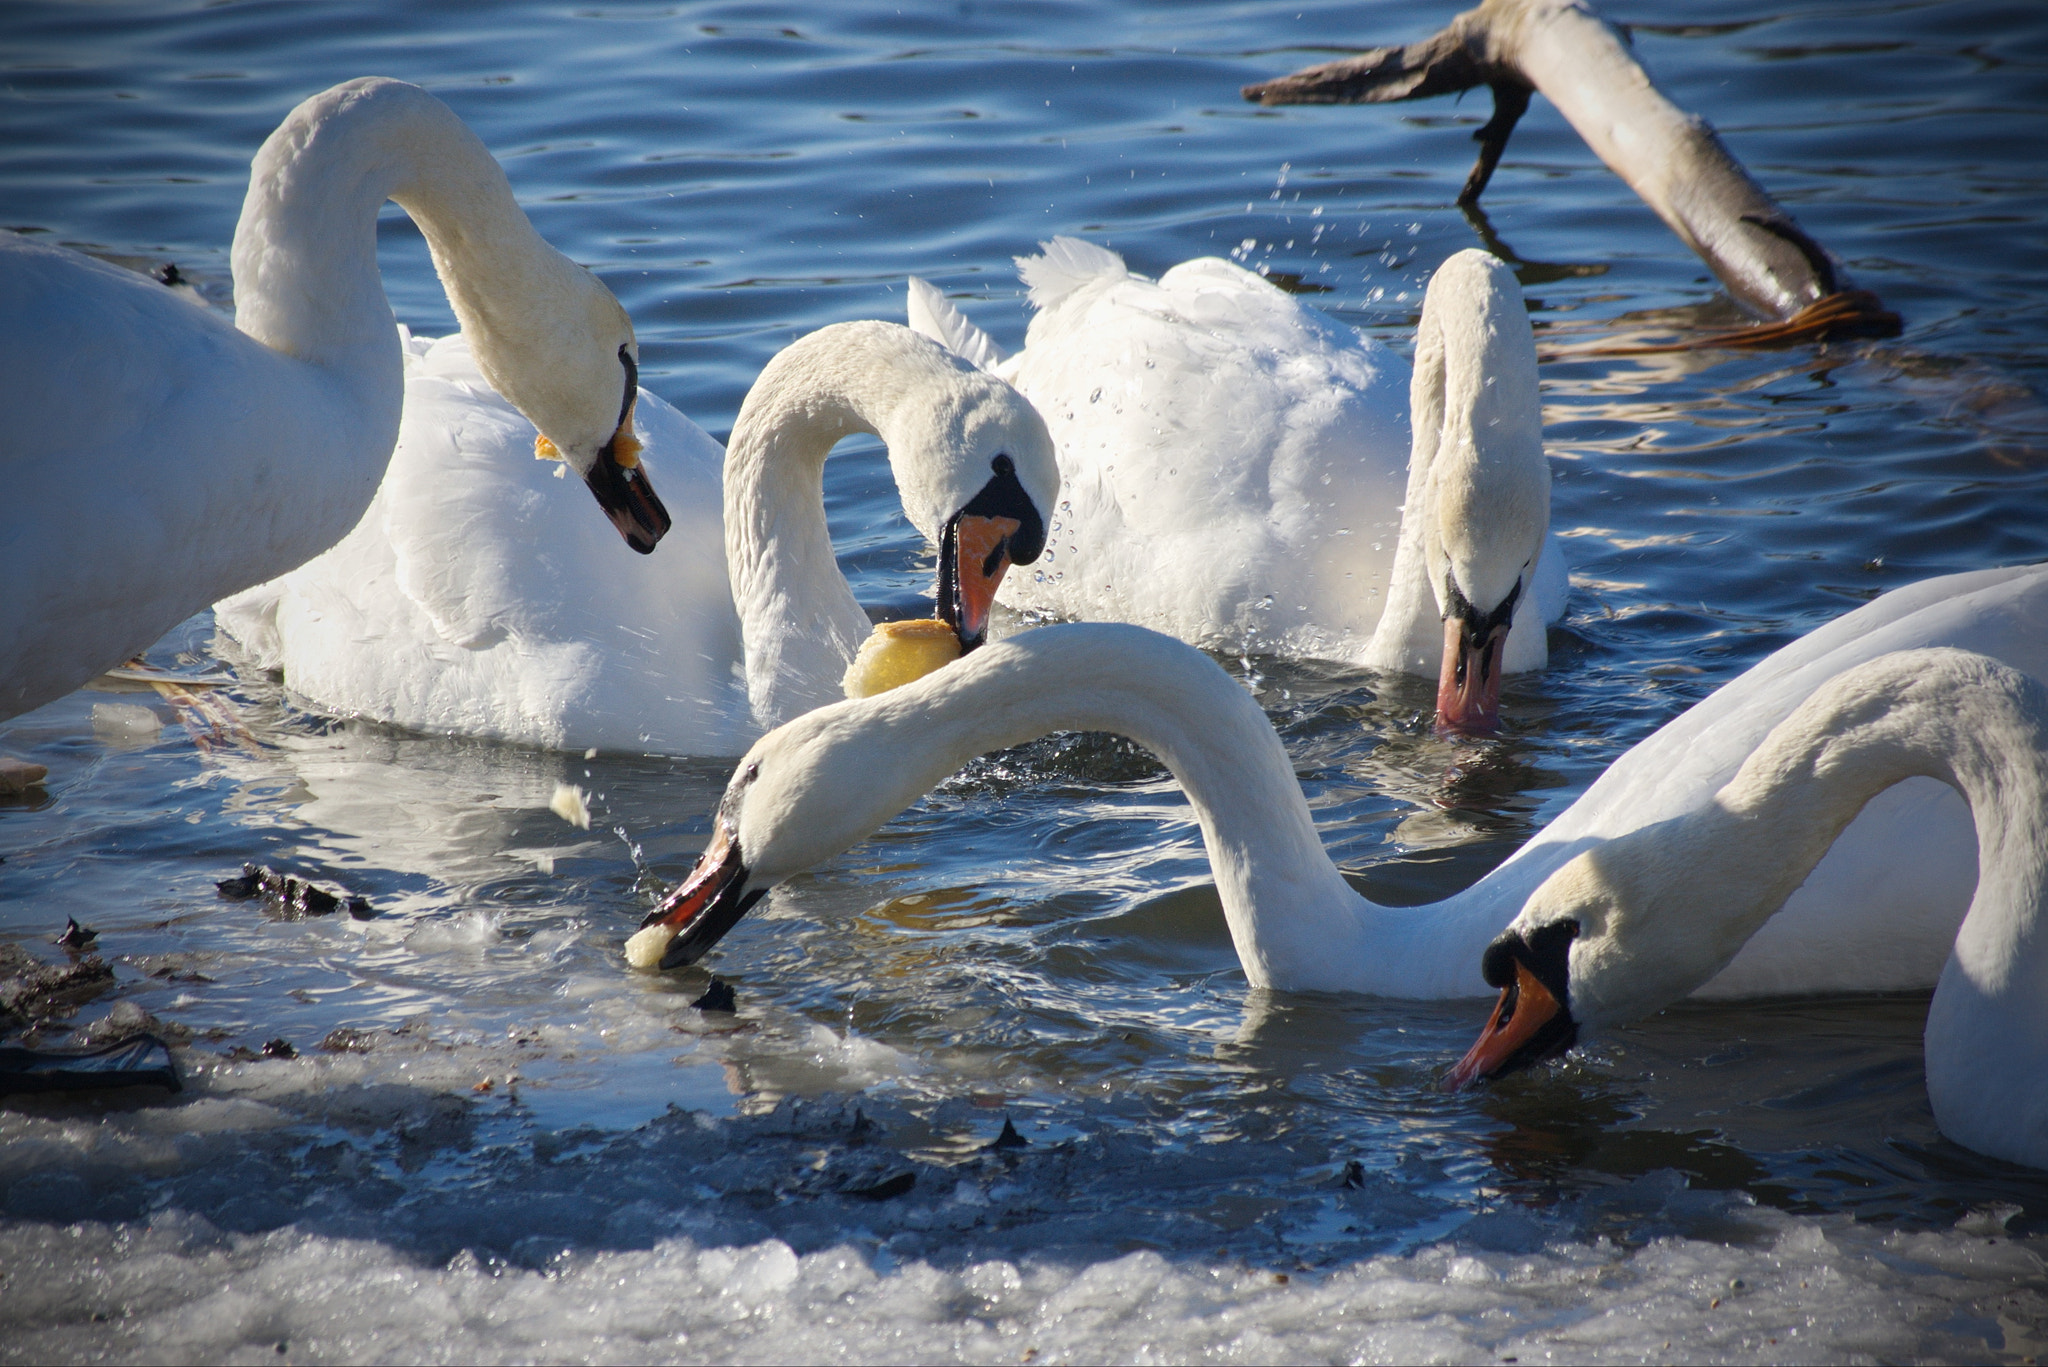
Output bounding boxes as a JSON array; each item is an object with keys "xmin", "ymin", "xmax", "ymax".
[{"xmin": 1368, "ymin": 250, "xmax": 1550, "ymax": 674}]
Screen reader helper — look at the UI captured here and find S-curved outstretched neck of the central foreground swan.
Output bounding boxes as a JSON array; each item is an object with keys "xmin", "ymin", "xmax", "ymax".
[{"xmin": 821, "ymin": 623, "xmax": 1507, "ymax": 996}]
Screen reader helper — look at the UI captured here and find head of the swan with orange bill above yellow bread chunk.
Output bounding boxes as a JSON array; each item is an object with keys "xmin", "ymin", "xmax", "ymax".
[{"xmin": 885, "ymin": 366, "xmax": 1059, "ymax": 652}]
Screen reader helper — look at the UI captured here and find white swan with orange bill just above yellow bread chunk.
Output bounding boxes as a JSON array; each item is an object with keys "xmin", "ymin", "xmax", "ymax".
[{"xmin": 215, "ymin": 322, "xmax": 1059, "ymax": 754}]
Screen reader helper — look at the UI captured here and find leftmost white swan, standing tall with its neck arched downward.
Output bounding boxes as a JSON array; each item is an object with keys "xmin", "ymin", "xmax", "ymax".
[{"xmin": 0, "ymin": 78, "xmax": 668, "ymax": 717}]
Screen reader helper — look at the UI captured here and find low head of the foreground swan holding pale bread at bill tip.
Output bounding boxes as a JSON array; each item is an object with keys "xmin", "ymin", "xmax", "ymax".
[{"xmin": 627, "ymin": 696, "xmax": 946, "ymax": 969}]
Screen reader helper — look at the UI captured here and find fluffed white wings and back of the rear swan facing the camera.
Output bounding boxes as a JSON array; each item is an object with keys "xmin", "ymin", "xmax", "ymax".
[{"xmin": 1004, "ymin": 242, "xmax": 1407, "ymax": 658}]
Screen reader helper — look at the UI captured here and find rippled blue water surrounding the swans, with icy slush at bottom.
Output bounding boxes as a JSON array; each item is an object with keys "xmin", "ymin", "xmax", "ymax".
[{"xmin": 0, "ymin": 0, "xmax": 2048, "ymax": 1361}]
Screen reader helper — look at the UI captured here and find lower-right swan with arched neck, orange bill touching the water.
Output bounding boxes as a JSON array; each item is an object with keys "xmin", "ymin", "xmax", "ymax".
[{"xmin": 1446, "ymin": 650, "xmax": 2048, "ymax": 1168}]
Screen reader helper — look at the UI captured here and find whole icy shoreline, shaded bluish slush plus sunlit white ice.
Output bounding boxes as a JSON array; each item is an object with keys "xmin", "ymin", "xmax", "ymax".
[{"xmin": 0, "ymin": 1039, "xmax": 2048, "ymax": 1363}]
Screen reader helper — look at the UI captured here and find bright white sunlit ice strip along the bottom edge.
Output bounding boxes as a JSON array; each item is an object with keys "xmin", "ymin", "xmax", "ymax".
[{"xmin": 0, "ymin": 1211, "xmax": 2048, "ymax": 1363}]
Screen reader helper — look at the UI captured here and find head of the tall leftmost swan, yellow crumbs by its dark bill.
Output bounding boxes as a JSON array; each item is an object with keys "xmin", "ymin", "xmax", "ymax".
[{"xmin": 458, "ymin": 259, "xmax": 670, "ymax": 555}]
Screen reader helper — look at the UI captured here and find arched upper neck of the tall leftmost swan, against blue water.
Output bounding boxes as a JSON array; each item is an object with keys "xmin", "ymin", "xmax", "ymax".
[{"xmin": 231, "ymin": 78, "xmax": 567, "ymax": 381}]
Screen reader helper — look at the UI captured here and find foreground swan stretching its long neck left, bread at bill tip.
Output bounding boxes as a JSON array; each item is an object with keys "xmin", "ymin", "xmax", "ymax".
[{"xmin": 635, "ymin": 566, "xmax": 2048, "ymax": 998}]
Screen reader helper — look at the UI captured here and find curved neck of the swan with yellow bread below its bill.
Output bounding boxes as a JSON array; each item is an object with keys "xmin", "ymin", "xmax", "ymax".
[{"xmin": 725, "ymin": 322, "xmax": 987, "ymax": 726}]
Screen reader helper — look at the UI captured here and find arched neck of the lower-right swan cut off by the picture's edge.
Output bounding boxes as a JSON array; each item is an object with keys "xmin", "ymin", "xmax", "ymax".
[{"xmin": 1564, "ymin": 650, "xmax": 2048, "ymax": 1024}]
